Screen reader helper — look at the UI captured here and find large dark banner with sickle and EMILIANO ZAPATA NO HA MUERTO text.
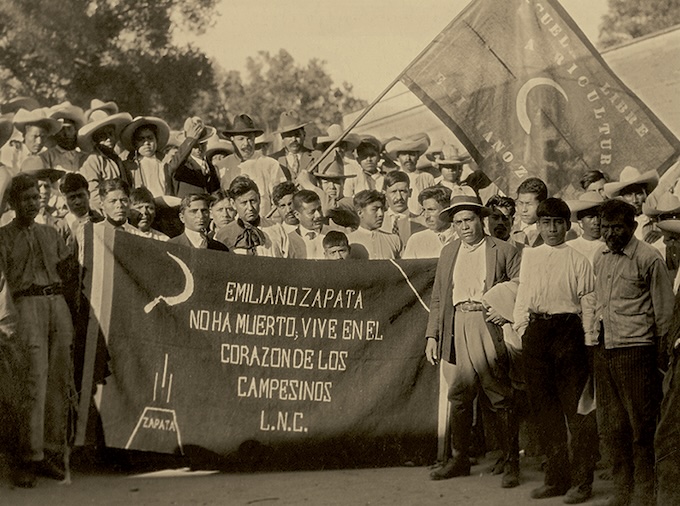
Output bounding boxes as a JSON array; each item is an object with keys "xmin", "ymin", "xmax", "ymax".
[{"xmin": 79, "ymin": 229, "xmax": 439, "ymax": 461}]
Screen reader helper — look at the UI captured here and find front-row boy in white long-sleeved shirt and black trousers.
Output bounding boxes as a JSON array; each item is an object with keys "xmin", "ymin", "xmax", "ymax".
[{"xmin": 513, "ymin": 198, "xmax": 595, "ymax": 504}]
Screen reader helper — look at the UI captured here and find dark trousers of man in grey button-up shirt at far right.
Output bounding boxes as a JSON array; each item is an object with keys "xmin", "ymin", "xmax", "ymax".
[{"xmin": 595, "ymin": 345, "xmax": 661, "ymax": 505}]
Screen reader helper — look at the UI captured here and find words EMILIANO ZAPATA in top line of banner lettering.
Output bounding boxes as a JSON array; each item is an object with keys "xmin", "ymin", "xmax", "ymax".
[{"xmin": 224, "ymin": 281, "xmax": 364, "ymax": 309}]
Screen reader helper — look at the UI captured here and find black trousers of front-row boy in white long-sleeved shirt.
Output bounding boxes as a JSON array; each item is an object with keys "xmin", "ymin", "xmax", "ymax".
[{"xmin": 522, "ymin": 314, "xmax": 594, "ymax": 490}]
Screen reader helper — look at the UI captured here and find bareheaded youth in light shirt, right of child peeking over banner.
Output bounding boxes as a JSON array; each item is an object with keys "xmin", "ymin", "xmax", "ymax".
[{"xmin": 347, "ymin": 190, "xmax": 402, "ymax": 260}]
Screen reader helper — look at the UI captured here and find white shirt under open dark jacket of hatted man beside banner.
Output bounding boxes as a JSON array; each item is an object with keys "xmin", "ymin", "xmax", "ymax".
[{"xmin": 452, "ymin": 237, "xmax": 486, "ymax": 306}]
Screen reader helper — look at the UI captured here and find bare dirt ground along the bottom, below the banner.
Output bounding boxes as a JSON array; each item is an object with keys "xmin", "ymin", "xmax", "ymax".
[{"xmin": 0, "ymin": 450, "xmax": 611, "ymax": 506}]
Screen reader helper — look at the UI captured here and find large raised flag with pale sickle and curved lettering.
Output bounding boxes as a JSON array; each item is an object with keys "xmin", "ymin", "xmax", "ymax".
[{"xmin": 402, "ymin": 0, "xmax": 680, "ymax": 196}]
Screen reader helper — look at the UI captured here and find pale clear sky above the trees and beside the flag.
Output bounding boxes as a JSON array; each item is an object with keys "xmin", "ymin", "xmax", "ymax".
[{"xmin": 176, "ymin": 0, "xmax": 607, "ymax": 102}]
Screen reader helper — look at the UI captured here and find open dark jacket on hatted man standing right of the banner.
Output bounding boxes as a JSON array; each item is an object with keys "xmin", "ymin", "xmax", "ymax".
[{"xmin": 425, "ymin": 236, "xmax": 520, "ymax": 364}]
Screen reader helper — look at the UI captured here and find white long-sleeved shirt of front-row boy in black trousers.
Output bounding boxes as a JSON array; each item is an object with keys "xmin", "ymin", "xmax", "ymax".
[{"xmin": 513, "ymin": 243, "xmax": 595, "ymax": 336}]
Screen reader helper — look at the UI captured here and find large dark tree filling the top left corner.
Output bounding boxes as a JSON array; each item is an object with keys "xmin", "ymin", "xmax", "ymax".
[{"xmin": 0, "ymin": 0, "xmax": 217, "ymax": 124}]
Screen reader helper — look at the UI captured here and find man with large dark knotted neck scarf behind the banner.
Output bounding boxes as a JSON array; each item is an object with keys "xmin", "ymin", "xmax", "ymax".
[{"xmin": 215, "ymin": 176, "xmax": 289, "ymax": 258}]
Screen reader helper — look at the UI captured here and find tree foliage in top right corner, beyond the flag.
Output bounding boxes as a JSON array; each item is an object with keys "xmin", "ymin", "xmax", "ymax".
[{"xmin": 598, "ymin": 0, "xmax": 680, "ymax": 48}]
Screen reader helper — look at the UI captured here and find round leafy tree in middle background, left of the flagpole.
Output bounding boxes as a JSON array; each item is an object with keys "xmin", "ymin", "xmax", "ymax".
[{"xmin": 220, "ymin": 49, "xmax": 368, "ymax": 134}]
